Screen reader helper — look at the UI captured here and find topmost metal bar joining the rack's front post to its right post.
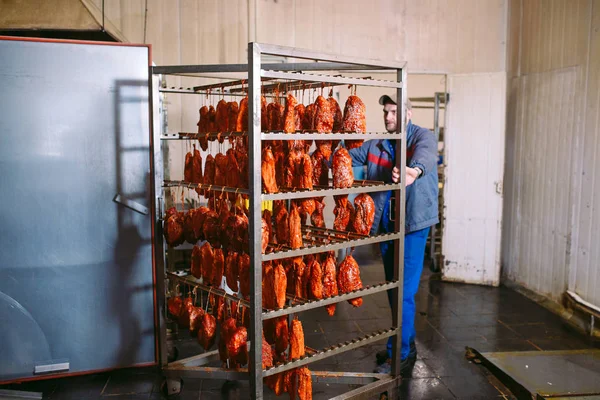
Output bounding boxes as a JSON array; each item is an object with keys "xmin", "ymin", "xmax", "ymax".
[{"xmin": 257, "ymin": 43, "xmax": 406, "ymax": 69}]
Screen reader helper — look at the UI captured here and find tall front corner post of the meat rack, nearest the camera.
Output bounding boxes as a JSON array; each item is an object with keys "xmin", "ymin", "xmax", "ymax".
[{"xmin": 248, "ymin": 43, "xmax": 263, "ymax": 399}]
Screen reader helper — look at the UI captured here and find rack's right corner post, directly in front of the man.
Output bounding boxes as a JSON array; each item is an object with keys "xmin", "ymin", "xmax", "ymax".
[{"xmin": 392, "ymin": 65, "xmax": 408, "ymax": 376}]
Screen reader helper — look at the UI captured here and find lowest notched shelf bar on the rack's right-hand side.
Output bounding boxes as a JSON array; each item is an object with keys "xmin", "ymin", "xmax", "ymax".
[{"xmin": 263, "ymin": 328, "xmax": 400, "ymax": 376}]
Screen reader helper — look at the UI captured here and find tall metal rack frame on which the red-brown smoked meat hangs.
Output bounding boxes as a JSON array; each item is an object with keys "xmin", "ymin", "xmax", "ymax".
[{"xmin": 152, "ymin": 43, "xmax": 406, "ymax": 399}]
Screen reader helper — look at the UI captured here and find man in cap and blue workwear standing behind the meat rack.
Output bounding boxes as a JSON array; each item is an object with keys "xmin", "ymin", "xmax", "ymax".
[{"xmin": 350, "ymin": 95, "xmax": 439, "ymax": 375}]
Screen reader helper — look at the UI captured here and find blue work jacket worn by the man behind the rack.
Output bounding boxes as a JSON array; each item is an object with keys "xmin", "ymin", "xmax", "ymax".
[{"xmin": 350, "ymin": 122, "xmax": 439, "ymax": 235}]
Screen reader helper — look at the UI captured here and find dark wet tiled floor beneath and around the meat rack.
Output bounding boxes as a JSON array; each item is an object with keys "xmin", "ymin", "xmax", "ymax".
[{"xmin": 0, "ymin": 248, "xmax": 594, "ymax": 400}]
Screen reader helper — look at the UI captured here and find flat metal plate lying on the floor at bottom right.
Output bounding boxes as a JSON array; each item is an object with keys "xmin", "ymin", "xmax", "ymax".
[{"xmin": 480, "ymin": 349, "xmax": 600, "ymax": 400}]
